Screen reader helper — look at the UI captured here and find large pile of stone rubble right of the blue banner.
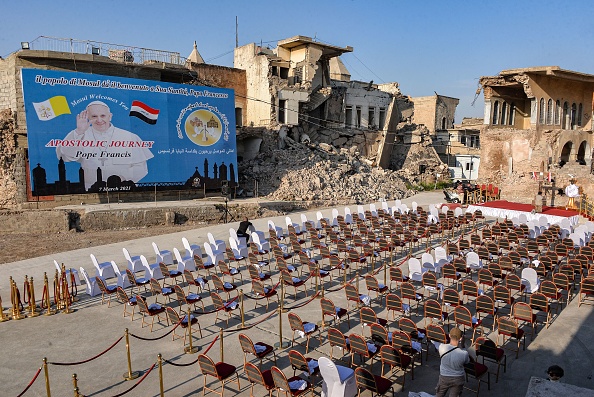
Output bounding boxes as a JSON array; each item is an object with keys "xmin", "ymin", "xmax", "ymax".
[{"xmin": 239, "ymin": 137, "xmax": 414, "ymax": 205}]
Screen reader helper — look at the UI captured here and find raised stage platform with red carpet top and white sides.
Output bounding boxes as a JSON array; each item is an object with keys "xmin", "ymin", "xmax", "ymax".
[{"xmin": 466, "ymin": 200, "xmax": 579, "ymax": 226}]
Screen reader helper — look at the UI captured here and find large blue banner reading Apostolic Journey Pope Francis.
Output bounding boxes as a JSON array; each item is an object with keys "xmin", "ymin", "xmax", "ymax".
[{"xmin": 21, "ymin": 69, "xmax": 237, "ymax": 195}]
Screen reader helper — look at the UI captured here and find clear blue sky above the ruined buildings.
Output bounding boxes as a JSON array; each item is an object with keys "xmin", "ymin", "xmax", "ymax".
[{"xmin": 0, "ymin": 0, "xmax": 594, "ymax": 122}]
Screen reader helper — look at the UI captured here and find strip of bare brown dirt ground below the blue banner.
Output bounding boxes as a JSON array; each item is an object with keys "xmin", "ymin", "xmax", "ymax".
[{"xmin": 0, "ymin": 225, "xmax": 200, "ymax": 264}]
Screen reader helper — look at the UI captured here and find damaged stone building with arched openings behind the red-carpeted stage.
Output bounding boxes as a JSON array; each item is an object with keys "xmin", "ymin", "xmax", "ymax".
[{"xmin": 479, "ymin": 66, "xmax": 594, "ymax": 200}]
